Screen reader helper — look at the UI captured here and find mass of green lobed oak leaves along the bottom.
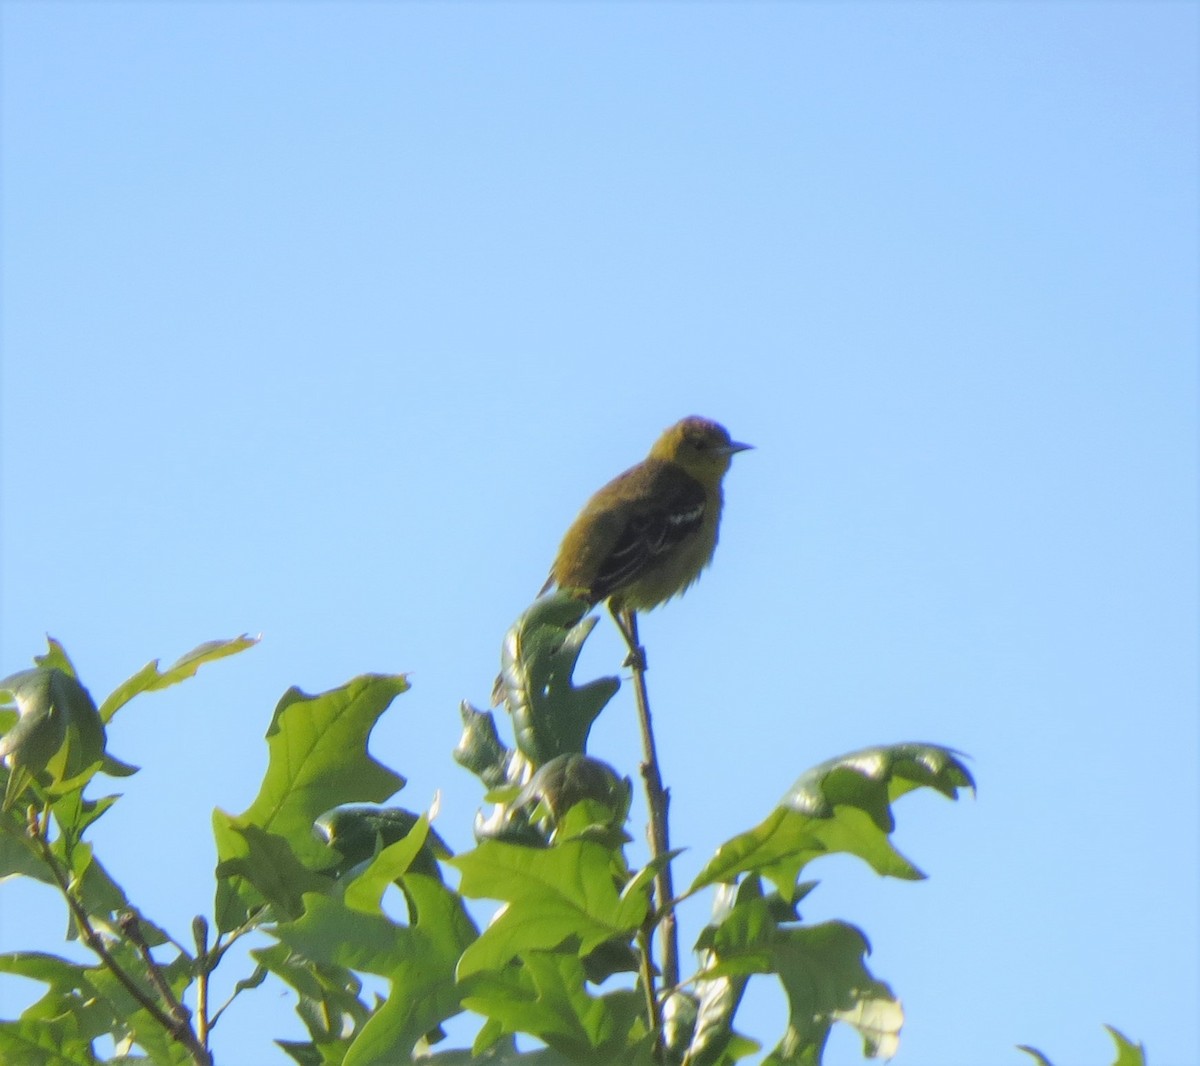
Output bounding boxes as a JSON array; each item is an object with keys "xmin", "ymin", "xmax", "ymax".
[{"xmin": 0, "ymin": 595, "xmax": 1140, "ymax": 1066}]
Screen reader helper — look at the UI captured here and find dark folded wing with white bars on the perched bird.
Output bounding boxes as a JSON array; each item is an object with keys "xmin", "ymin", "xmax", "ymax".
[{"xmin": 592, "ymin": 471, "xmax": 707, "ymax": 603}]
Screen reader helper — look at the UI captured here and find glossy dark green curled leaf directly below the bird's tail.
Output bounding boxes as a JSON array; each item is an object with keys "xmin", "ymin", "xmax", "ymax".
[{"xmin": 500, "ymin": 592, "xmax": 620, "ymax": 766}]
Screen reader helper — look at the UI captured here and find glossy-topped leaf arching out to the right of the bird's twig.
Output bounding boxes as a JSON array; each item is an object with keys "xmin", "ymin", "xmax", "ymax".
[{"xmin": 688, "ymin": 744, "xmax": 974, "ymax": 898}]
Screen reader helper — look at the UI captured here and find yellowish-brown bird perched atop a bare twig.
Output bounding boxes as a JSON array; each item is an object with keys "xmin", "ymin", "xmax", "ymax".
[{"xmin": 541, "ymin": 415, "xmax": 752, "ymax": 618}]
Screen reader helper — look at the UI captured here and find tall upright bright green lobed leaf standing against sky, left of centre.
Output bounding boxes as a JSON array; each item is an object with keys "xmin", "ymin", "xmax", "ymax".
[{"xmin": 212, "ymin": 675, "xmax": 408, "ymax": 932}]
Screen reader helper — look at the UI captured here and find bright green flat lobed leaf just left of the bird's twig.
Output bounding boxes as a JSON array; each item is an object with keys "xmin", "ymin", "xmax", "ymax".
[{"xmin": 449, "ymin": 839, "xmax": 649, "ymax": 976}]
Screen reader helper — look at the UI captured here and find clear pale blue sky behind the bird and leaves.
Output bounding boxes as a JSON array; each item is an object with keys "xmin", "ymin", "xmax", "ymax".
[{"xmin": 0, "ymin": 0, "xmax": 1200, "ymax": 1066}]
